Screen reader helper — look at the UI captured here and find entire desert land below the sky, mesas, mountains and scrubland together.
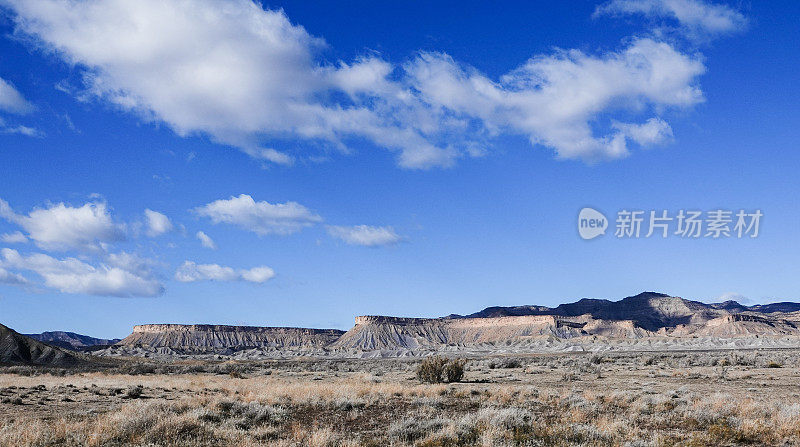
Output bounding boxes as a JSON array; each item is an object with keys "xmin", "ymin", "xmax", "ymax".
[{"xmin": 0, "ymin": 293, "xmax": 800, "ymax": 447}]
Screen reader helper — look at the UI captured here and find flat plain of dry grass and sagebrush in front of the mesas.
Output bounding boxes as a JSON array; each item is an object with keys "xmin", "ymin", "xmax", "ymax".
[{"xmin": 0, "ymin": 349, "xmax": 800, "ymax": 446}]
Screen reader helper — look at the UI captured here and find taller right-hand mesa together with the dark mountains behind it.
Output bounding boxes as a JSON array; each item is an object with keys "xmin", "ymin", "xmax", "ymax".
[{"xmin": 330, "ymin": 292, "xmax": 800, "ymax": 353}]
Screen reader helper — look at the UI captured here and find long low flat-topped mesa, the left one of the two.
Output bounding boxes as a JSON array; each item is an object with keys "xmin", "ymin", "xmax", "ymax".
[{"xmin": 118, "ymin": 324, "xmax": 344, "ymax": 351}]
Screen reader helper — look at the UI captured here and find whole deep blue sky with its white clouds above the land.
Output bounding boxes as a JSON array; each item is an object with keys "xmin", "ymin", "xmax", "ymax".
[{"xmin": 0, "ymin": 0, "xmax": 800, "ymax": 337}]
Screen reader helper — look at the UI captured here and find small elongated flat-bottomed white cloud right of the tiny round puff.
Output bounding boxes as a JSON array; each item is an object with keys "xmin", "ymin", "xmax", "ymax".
[{"xmin": 194, "ymin": 194, "xmax": 322, "ymax": 235}]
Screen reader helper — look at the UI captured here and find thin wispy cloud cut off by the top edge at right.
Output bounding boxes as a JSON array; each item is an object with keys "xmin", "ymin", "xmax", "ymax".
[{"xmin": 595, "ymin": 0, "xmax": 747, "ymax": 37}]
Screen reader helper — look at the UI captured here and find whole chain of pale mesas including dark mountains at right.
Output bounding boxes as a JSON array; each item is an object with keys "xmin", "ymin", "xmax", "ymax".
[{"xmin": 92, "ymin": 292, "xmax": 800, "ymax": 359}]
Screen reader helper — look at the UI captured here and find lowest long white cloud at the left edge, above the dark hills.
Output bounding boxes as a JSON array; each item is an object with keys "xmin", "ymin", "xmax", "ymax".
[{"xmin": 0, "ymin": 248, "xmax": 164, "ymax": 297}]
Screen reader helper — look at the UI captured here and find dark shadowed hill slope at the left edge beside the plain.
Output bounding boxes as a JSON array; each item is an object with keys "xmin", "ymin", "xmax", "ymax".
[{"xmin": 0, "ymin": 324, "xmax": 89, "ymax": 367}]
